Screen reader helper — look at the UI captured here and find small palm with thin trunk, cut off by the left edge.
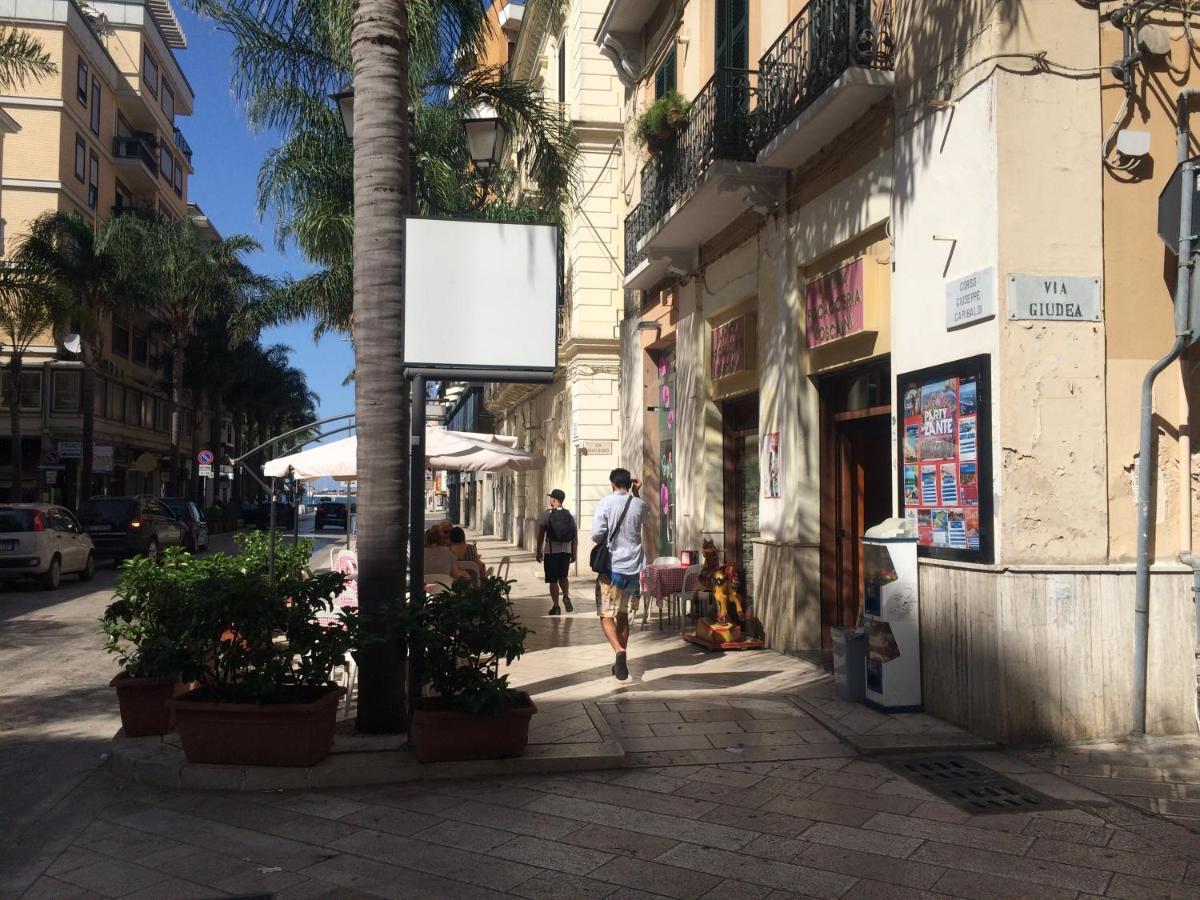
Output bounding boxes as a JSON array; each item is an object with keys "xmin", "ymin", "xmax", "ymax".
[{"xmin": 0, "ymin": 265, "xmax": 66, "ymax": 502}]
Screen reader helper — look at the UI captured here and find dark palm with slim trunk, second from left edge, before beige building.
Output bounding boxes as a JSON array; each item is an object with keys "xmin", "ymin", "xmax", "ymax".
[{"xmin": 14, "ymin": 212, "xmax": 152, "ymax": 500}]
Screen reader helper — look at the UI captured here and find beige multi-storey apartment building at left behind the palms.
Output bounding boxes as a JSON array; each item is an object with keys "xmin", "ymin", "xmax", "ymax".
[{"xmin": 0, "ymin": 0, "xmax": 201, "ymax": 504}]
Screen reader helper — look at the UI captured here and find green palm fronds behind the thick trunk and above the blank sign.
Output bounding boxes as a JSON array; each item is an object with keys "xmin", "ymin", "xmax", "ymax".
[{"xmin": 178, "ymin": 0, "xmax": 577, "ymax": 336}]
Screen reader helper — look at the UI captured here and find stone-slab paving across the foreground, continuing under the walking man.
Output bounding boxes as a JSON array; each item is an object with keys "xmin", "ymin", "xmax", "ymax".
[{"xmin": 0, "ymin": 532, "xmax": 1200, "ymax": 900}]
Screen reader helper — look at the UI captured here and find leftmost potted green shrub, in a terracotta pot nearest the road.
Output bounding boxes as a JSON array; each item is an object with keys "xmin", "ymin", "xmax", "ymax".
[{"xmin": 100, "ymin": 551, "xmax": 198, "ymax": 738}]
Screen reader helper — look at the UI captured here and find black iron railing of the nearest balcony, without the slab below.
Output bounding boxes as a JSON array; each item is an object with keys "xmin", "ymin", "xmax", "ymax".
[{"xmin": 758, "ymin": 0, "xmax": 895, "ymax": 143}]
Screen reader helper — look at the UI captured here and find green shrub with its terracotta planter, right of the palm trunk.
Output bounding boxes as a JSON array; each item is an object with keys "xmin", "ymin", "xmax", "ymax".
[{"xmin": 402, "ymin": 577, "xmax": 538, "ymax": 762}]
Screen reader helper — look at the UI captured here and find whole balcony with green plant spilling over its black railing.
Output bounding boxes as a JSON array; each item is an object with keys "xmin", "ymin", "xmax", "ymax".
[{"xmin": 625, "ymin": 68, "xmax": 782, "ymax": 290}]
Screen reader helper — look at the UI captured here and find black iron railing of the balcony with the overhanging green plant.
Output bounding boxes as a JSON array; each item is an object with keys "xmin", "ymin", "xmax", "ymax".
[{"xmin": 625, "ymin": 68, "xmax": 758, "ymax": 274}]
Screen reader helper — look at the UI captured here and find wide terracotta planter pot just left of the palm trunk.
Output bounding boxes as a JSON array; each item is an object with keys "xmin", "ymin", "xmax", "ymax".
[{"xmin": 170, "ymin": 688, "xmax": 342, "ymax": 766}]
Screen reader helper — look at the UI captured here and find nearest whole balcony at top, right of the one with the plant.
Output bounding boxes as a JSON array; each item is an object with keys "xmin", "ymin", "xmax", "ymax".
[{"xmin": 758, "ymin": 0, "xmax": 895, "ymax": 169}]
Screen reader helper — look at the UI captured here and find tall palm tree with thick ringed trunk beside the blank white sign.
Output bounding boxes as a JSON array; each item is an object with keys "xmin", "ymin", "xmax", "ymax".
[{"xmin": 188, "ymin": 0, "xmax": 574, "ymax": 732}]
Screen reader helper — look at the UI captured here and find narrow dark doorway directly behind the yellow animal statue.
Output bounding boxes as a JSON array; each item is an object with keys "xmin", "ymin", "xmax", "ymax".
[{"xmin": 721, "ymin": 394, "xmax": 760, "ymax": 599}]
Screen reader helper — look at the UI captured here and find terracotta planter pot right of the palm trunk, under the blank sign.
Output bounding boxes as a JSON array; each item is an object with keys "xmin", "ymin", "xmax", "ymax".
[{"xmin": 409, "ymin": 692, "xmax": 538, "ymax": 762}]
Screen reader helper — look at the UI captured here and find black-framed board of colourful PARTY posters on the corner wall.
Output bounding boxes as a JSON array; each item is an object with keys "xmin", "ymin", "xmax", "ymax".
[{"xmin": 896, "ymin": 354, "xmax": 994, "ymax": 563}]
